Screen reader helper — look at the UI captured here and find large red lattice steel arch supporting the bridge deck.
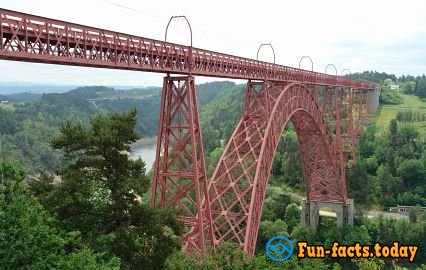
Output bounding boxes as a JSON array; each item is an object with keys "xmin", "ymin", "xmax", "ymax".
[{"xmin": 208, "ymin": 82, "xmax": 347, "ymax": 255}]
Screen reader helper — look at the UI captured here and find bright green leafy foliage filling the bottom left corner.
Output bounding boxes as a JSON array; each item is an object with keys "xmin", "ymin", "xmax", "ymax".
[{"xmin": 0, "ymin": 163, "xmax": 120, "ymax": 269}]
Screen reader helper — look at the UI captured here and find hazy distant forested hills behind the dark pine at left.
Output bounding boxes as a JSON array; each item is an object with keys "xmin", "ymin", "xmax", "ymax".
[{"xmin": 0, "ymin": 82, "xmax": 234, "ymax": 174}]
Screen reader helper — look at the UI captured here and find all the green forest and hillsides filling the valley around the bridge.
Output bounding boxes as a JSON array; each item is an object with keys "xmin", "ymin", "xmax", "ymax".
[{"xmin": 0, "ymin": 72, "xmax": 426, "ymax": 270}]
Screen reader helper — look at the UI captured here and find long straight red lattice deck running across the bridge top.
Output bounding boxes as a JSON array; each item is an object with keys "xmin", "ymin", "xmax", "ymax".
[{"xmin": 0, "ymin": 9, "xmax": 375, "ymax": 89}]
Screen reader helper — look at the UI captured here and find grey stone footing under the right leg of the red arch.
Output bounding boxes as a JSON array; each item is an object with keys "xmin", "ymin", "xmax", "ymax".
[{"xmin": 301, "ymin": 198, "xmax": 354, "ymax": 230}]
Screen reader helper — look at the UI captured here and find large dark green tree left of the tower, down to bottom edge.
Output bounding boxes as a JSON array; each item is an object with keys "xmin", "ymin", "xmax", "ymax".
[{"xmin": 47, "ymin": 109, "xmax": 181, "ymax": 269}]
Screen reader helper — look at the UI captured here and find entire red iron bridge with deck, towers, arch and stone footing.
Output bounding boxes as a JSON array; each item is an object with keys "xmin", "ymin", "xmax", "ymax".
[{"xmin": 0, "ymin": 9, "xmax": 380, "ymax": 255}]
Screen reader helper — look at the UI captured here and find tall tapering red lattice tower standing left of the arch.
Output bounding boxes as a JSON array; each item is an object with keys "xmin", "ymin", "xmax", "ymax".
[{"xmin": 151, "ymin": 76, "xmax": 215, "ymax": 251}]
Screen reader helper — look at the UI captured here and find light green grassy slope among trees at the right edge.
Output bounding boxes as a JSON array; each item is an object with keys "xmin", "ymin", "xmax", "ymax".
[{"xmin": 374, "ymin": 93, "xmax": 426, "ymax": 135}]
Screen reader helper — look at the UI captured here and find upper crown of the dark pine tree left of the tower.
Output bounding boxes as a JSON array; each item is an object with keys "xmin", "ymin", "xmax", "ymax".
[{"xmin": 52, "ymin": 109, "xmax": 149, "ymax": 227}]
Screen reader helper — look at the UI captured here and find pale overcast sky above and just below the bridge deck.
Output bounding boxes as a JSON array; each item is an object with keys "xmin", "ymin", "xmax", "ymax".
[{"xmin": 0, "ymin": 0, "xmax": 426, "ymax": 86}]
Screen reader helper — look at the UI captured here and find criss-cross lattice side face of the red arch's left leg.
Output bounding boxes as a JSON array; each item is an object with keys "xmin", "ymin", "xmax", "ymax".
[{"xmin": 209, "ymin": 82, "xmax": 278, "ymax": 246}]
